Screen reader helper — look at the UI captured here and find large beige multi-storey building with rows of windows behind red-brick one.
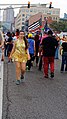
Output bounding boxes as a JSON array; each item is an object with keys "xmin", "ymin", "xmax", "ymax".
[{"xmin": 15, "ymin": 4, "xmax": 60, "ymax": 29}]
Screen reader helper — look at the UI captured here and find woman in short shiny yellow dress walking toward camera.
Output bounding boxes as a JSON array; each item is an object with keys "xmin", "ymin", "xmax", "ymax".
[{"xmin": 10, "ymin": 31, "xmax": 30, "ymax": 85}]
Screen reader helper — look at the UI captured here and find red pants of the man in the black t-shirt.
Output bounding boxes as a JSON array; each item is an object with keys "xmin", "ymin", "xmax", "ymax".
[{"xmin": 43, "ymin": 57, "xmax": 54, "ymax": 76}]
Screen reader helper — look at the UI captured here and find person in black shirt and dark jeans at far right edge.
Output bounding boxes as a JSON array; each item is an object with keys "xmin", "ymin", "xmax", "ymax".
[{"xmin": 60, "ymin": 41, "xmax": 67, "ymax": 72}]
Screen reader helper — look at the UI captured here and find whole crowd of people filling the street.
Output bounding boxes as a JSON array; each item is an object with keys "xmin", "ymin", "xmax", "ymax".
[{"xmin": 0, "ymin": 29, "xmax": 67, "ymax": 85}]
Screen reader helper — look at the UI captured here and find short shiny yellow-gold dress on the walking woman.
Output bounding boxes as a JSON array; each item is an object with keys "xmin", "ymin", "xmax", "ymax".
[{"xmin": 12, "ymin": 39, "xmax": 28, "ymax": 62}]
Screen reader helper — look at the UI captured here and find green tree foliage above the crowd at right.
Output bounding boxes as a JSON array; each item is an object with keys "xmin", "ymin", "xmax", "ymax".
[{"xmin": 50, "ymin": 21, "xmax": 67, "ymax": 32}]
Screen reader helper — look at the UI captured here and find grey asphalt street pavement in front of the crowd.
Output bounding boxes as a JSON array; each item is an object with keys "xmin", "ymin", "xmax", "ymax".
[{"xmin": 2, "ymin": 60, "xmax": 67, "ymax": 119}]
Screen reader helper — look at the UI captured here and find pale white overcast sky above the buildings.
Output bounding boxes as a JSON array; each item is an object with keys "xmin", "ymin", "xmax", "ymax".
[{"xmin": 0, "ymin": 0, "xmax": 67, "ymax": 18}]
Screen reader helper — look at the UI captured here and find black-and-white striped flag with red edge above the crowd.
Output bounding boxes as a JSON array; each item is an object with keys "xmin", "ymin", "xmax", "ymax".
[{"xmin": 28, "ymin": 18, "xmax": 42, "ymax": 32}]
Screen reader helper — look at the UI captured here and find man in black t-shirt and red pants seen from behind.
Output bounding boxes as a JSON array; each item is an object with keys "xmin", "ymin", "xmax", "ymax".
[{"xmin": 42, "ymin": 30, "xmax": 58, "ymax": 78}]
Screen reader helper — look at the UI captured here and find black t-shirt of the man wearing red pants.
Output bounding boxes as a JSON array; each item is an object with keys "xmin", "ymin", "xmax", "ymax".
[{"xmin": 42, "ymin": 36, "xmax": 58, "ymax": 57}]
